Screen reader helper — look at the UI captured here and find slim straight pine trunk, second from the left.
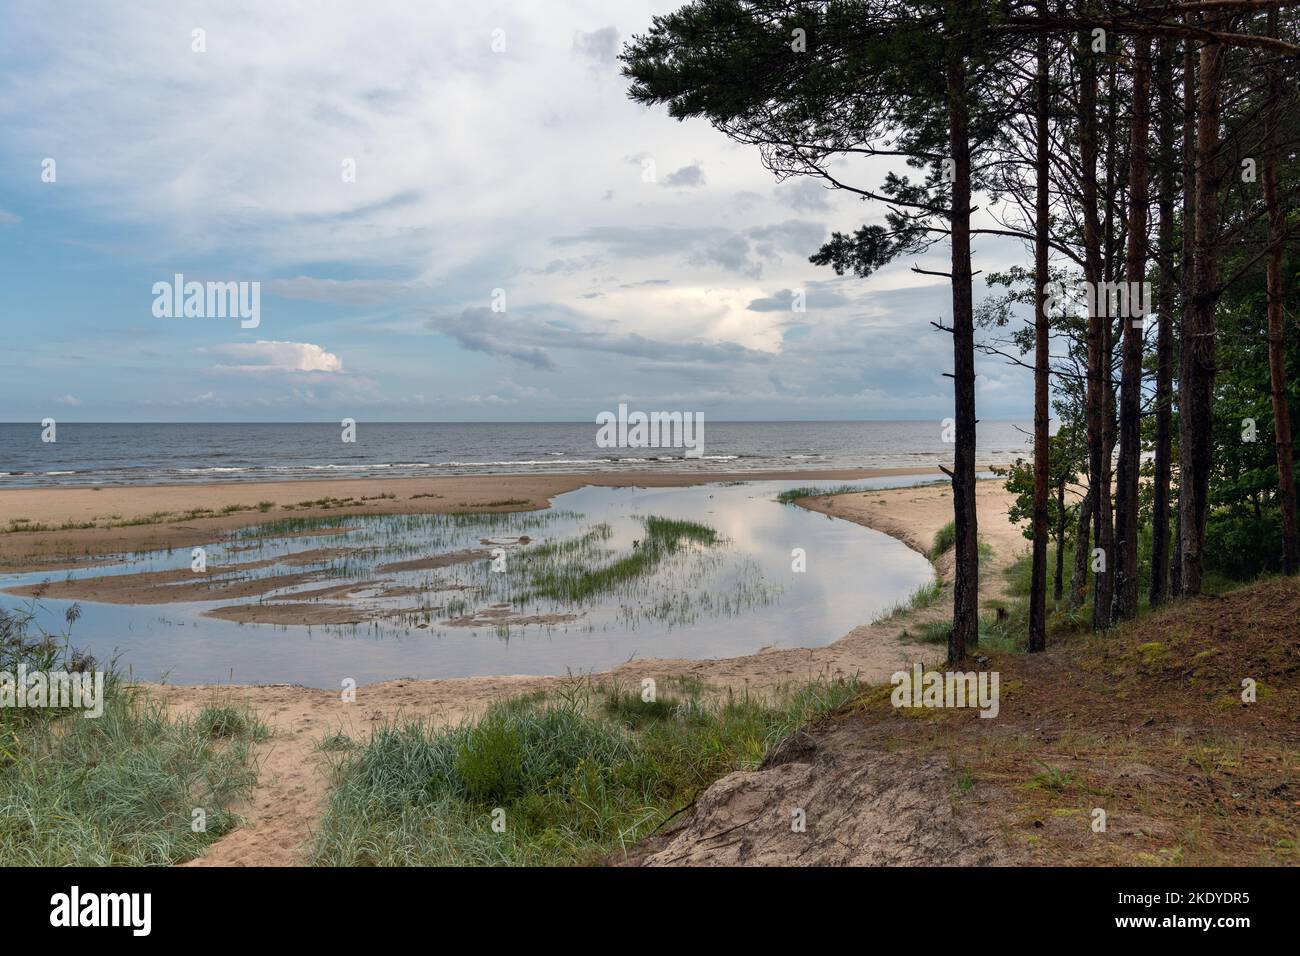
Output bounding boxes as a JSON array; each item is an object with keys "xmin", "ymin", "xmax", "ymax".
[{"xmin": 1030, "ymin": 9, "xmax": 1061, "ymax": 652}]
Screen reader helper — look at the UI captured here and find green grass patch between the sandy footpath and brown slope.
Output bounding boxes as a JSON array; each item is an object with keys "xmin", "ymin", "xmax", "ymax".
[{"xmin": 312, "ymin": 680, "xmax": 859, "ymax": 866}]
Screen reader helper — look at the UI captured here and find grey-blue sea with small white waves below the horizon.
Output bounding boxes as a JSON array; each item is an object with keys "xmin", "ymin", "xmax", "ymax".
[{"xmin": 0, "ymin": 420, "xmax": 1031, "ymax": 486}]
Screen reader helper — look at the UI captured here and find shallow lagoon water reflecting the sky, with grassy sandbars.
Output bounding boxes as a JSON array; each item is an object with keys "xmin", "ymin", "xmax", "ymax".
[{"xmin": 0, "ymin": 477, "xmax": 933, "ymax": 688}]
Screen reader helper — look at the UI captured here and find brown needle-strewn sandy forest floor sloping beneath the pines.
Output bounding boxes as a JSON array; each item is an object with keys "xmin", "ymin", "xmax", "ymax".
[{"xmin": 615, "ymin": 580, "xmax": 1300, "ymax": 866}]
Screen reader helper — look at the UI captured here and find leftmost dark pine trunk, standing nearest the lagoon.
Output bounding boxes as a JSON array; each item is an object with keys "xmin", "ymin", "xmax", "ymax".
[{"xmin": 948, "ymin": 52, "xmax": 979, "ymax": 665}]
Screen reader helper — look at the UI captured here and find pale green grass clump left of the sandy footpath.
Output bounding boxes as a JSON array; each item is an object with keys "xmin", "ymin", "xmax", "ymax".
[{"xmin": 0, "ymin": 611, "xmax": 267, "ymax": 866}]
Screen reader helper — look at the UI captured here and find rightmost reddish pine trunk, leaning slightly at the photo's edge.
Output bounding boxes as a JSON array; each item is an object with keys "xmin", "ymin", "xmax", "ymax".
[{"xmin": 1264, "ymin": 8, "xmax": 1300, "ymax": 575}]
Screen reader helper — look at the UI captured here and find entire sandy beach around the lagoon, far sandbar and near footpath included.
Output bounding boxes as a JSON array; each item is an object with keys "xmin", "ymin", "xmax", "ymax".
[{"xmin": 0, "ymin": 470, "xmax": 1027, "ymax": 865}]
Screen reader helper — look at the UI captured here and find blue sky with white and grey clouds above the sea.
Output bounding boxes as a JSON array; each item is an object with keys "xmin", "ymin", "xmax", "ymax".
[{"xmin": 0, "ymin": 0, "xmax": 1032, "ymax": 421}]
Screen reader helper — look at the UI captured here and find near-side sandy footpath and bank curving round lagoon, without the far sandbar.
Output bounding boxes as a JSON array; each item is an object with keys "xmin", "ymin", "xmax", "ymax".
[{"xmin": 152, "ymin": 481, "xmax": 1028, "ymax": 865}]
